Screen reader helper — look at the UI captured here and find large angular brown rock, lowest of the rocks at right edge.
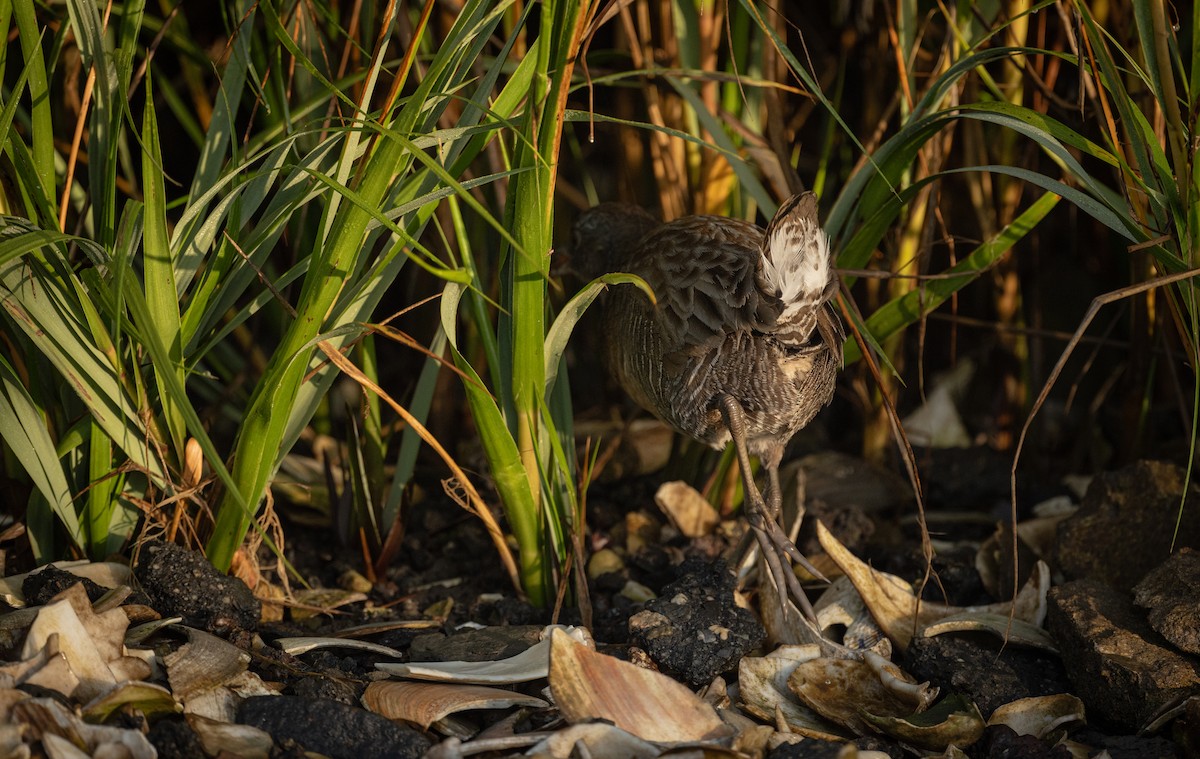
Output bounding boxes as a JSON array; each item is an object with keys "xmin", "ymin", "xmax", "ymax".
[{"xmin": 1046, "ymin": 580, "xmax": 1200, "ymax": 728}]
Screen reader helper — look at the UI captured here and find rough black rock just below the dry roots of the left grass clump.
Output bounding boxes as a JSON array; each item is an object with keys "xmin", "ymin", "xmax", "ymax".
[{"xmin": 133, "ymin": 540, "xmax": 260, "ymax": 634}]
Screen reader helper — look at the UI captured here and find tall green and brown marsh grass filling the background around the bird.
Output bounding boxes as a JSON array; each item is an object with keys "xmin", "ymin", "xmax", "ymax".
[{"xmin": 0, "ymin": 0, "xmax": 1200, "ymax": 604}]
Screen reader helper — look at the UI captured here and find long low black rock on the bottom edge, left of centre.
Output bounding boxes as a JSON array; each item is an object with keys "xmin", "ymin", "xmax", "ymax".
[{"xmin": 238, "ymin": 695, "xmax": 431, "ymax": 759}]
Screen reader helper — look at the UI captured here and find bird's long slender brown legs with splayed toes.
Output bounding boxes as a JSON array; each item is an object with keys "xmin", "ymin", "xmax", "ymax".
[{"xmin": 720, "ymin": 394, "xmax": 821, "ymax": 621}]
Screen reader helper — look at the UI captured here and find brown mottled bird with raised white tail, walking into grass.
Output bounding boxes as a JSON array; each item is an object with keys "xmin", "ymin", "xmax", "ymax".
[{"xmin": 570, "ymin": 192, "xmax": 845, "ymax": 620}]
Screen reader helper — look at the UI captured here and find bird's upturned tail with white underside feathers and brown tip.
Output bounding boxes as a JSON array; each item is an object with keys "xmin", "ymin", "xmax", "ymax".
[{"xmin": 761, "ymin": 192, "xmax": 838, "ymax": 346}]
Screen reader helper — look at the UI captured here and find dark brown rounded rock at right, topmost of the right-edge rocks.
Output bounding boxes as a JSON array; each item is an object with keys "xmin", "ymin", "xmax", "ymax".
[{"xmin": 1056, "ymin": 461, "xmax": 1200, "ymax": 591}]
